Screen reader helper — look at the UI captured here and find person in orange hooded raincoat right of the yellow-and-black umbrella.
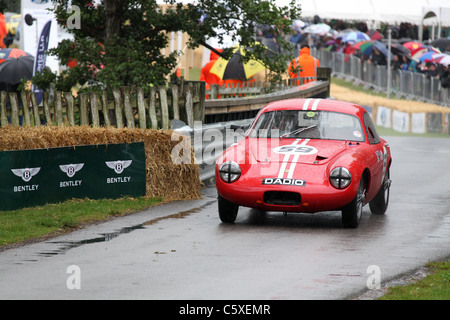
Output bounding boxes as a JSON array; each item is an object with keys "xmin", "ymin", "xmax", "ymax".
[{"xmin": 288, "ymin": 44, "xmax": 320, "ymax": 85}]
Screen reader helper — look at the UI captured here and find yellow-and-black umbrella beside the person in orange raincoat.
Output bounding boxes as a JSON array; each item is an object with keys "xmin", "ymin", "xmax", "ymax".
[{"xmin": 209, "ymin": 45, "xmax": 266, "ymax": 81}]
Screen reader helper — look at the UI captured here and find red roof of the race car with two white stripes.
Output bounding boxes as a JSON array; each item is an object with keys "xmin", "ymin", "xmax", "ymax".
[{"xmin": 261, "ymin": 98, "xmax": 365, "ymax": 116}]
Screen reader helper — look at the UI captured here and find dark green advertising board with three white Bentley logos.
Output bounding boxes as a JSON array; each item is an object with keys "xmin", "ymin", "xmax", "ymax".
[{"xmin": 0, "ymin": 142, "xmax": 146, "ymax": 210}]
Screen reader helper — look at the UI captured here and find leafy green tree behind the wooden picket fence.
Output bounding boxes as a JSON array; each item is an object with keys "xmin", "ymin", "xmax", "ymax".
[{"xmin": 33, "ymin": 0, "xmax": 300, "ymax": 91}]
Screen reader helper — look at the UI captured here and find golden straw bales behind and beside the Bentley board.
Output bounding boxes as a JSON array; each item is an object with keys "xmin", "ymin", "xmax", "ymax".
[{"xmin": 0, "ymin": 126, "xmax": 202, "ymax": 200}]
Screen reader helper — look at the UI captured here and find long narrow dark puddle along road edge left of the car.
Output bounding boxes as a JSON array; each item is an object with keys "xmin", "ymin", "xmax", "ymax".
[{"xmin": 38, "ymin": 201, "xmax": 215, "ymax": 257}]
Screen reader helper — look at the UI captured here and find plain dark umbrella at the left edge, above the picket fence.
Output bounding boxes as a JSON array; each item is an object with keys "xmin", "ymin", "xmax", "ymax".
[{"xmin": 0, "ymin": 56, "xmax": 34, "ymax": 84}]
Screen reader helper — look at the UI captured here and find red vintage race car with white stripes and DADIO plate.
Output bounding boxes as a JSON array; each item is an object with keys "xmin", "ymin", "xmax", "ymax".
[{"xmin": 215, "ymin": 99, "xmax": 392, "ymax": 228}]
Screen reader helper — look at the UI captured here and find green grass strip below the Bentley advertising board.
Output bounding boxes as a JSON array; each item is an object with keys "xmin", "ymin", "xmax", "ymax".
[{"xmin": 0, "ymin": 197, "xmax": 162, "ymax": 249}]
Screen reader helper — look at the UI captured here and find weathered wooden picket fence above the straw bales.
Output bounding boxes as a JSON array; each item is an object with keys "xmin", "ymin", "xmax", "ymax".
[{"xmin": 0, "ymin": 81, "xmax": 205, "ymax": 129}]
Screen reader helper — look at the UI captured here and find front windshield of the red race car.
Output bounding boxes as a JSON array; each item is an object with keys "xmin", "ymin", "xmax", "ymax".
[{"xmin": 249, "ymin": 110, "xmax": 364, "ymax": 142}]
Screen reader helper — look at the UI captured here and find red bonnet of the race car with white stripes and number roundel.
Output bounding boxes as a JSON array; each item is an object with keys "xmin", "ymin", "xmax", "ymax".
[{"xmin": 249, "ymin": 139, "xmax": 355, "ymax": 164}]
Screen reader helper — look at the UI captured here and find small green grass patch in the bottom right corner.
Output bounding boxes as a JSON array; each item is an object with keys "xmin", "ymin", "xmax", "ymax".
[{"xmin": 379, "ymin": 261, "xmax": 450, "ymax": 300}]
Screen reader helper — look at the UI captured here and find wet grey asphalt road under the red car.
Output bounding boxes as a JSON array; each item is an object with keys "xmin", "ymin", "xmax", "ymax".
[{"xmin": 0, "ymin": 137, "xmax": 450, "ymax": 299}]
